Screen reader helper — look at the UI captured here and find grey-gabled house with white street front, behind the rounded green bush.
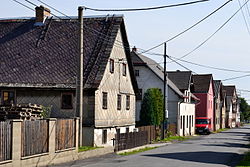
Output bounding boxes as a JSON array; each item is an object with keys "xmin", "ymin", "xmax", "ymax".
[{"xmin": 131, "ymin": 48, "xmax": 197, "ymax": 135}]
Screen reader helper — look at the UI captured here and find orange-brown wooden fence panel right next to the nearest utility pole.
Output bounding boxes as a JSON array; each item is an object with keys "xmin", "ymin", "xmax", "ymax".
[{"xmin": 56, "ymin": 119, "xmax": 76, "ymax": 151}]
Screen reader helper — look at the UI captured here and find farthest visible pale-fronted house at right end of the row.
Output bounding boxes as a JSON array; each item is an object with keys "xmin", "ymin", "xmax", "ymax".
[{"xmin": 223, "ymin": 85, "xmax": 240, "ymax": 128}]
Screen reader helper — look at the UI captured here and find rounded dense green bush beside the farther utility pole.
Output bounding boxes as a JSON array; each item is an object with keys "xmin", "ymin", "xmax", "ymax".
[{"xmin": 140, "ymin": 88, "xmax": 163, "ymax": 125}]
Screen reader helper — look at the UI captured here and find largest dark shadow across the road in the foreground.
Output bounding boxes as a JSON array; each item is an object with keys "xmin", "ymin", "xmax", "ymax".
[{"xmin": 144, "ymin": 151, "xmax": 241, "ymax": 166}]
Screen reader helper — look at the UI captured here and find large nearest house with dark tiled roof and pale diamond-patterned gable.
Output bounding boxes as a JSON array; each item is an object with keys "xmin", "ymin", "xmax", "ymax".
[{"xmin": 0, "ymin": 7, "xmax": 137, "ymax": 146}]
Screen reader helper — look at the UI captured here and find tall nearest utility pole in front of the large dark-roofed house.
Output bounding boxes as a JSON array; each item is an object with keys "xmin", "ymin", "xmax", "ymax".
[{"xmin": 76, "ymin": 6, "xmax": 83, "ymax": 146}]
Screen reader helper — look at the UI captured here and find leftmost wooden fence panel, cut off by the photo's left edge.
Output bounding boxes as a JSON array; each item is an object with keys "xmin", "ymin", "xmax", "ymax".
[{"xmin": 0, "ymin": 121, "xmax": 12, "ymax": 161}]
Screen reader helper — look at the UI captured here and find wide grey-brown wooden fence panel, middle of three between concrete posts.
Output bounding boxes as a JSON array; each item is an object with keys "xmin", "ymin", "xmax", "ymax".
[{"xmin": 21, "ymin": 120, "xmax": 49, "ymax": 157}]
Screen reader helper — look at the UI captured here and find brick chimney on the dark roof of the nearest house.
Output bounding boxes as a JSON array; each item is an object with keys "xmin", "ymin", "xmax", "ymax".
[{"xmin": 36, "ymin": 5, "xmax": 50, "ymax": 26}]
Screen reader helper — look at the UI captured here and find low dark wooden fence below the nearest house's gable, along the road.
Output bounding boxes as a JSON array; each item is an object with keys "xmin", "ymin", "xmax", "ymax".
[{"xmin": 115, "ymin": 131, "xmax": 148, "ymax": 151}]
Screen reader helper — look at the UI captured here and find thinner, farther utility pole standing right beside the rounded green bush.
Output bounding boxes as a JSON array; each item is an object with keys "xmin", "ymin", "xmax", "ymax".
[{"xmin": 162, "ymin": 42, "xmax": 167, "ymax": 139}]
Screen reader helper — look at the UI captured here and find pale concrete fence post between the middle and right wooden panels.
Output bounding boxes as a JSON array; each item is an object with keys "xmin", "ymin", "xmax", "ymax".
[{"xmin": 49, "ymin": 118, "xmax": 56, "ymax": 155}]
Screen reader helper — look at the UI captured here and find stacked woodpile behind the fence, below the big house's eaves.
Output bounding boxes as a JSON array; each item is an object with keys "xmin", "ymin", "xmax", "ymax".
[{"xmin": 0, "ymin": 103, "xmax": 42, "ymax": 120}]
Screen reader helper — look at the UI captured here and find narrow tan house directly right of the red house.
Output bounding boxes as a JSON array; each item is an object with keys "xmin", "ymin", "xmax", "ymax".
[{"xmin": 214, "ymin": 80, "xmax": 226, "ymax": 130}]
